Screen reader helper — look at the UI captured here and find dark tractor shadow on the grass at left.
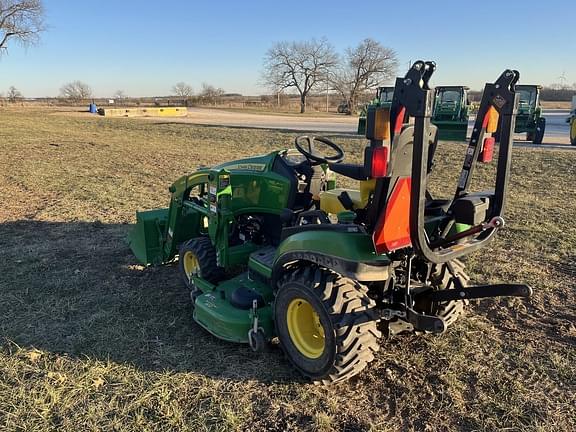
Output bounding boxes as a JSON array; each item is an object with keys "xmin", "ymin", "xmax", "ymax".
[{"xmin": 0, "ymin": 220, "xmax": 301, "ymax": 382}]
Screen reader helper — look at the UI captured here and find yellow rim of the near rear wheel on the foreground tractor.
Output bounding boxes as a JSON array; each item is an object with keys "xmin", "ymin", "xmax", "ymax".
[{"xmin": 286, "ymin": 298, "xmax": 325, "ymax": 359}]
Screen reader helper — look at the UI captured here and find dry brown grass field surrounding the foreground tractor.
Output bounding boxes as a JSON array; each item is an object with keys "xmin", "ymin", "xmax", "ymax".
[{"xmin": 0, "ymin": 109, "xmax": 576, "ymax": 432}]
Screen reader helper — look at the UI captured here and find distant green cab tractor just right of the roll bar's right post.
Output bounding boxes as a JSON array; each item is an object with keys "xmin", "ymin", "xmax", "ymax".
[{"xmin": 514, "ymin": 84, "xmax": 546, "ymax": 144}]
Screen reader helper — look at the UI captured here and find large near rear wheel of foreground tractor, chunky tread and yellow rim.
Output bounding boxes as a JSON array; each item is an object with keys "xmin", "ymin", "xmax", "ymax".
[{"xmin": 274, "ymin": 267, "xmax": 381, "ymax": 384}]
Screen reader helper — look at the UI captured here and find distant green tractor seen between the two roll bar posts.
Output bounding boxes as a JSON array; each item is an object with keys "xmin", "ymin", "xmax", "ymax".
[{"xmin": 432, "ymin": 86, "xmax": 470, "ymax": 141}]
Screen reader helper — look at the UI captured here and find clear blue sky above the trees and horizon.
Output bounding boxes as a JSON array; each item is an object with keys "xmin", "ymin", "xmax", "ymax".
[{"xmin": 0, "ymin": 0, "xmax": 576, "ymax": 97}]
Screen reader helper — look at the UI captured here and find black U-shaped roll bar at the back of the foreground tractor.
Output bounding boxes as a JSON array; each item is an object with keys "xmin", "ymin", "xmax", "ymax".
[{"xmin": 390, "ymin": 61, "xmax": 519, "ymax": 264}]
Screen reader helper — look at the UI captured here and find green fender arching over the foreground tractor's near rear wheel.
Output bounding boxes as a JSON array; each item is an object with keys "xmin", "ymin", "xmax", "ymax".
[{"xmin": 271, "ymin": 230, "xmax": 391, "ymax": 286}]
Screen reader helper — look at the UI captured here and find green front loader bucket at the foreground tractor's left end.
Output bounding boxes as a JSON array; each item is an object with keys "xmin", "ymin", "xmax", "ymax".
[{"xmin": 128, "ymin": 208, "xmax": 168, "ymax": 265}]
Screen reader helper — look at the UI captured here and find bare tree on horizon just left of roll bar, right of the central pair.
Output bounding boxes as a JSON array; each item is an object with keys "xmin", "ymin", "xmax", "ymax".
[{"xmin": 332, "ymin": 38, "xmax": 398, "ymax": 114}]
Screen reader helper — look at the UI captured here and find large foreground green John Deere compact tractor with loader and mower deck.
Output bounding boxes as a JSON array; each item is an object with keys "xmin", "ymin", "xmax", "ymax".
[{"xmin": 130, "ymin": 61, "xmax": 531, "ymax": 384}]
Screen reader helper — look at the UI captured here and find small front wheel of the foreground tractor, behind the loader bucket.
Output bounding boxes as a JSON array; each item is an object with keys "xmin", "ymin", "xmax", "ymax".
[{"xmin": 178, "ymin": 237, "xmax": 222, "ymax": 292}]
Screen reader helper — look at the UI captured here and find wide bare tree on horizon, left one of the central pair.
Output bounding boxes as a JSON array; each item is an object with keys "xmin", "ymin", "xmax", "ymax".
[{"xmin": 262, "ymin": 39, "xmax": 338, "ymax": 113}]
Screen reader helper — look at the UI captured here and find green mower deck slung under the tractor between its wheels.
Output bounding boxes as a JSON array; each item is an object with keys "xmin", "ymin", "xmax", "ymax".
[{"xmin": 194, "ymin": 273, "xmax": 274, "ymax": 343}]
